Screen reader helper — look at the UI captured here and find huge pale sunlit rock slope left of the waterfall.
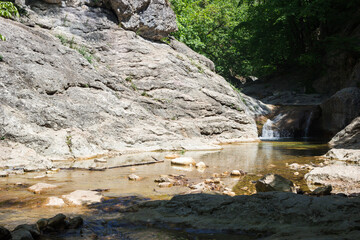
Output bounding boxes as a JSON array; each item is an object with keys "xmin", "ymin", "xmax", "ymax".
[{"xmin": 0, "ymin": 2, "xmax": 257, "ymax": 169}]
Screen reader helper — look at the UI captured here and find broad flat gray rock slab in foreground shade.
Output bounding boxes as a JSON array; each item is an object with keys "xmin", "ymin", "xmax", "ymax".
[{"xmin": 123, "ymin": 192, "xmax": 360, "ymax": 239}]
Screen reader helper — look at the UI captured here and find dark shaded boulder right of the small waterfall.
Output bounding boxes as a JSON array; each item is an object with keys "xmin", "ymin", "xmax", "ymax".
[{"xmin": 320, "ymin": 87, "xmax": 360, "ymax": 136}]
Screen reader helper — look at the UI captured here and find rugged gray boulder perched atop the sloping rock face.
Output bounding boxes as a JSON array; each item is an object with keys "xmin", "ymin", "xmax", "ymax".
[{"xmin": 108, "ymin": 0, "xmax": 177, "ymax": 40}]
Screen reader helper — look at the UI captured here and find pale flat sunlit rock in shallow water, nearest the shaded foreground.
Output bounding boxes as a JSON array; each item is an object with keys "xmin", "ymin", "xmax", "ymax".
[{"xmin": 62, "ymin": 190, "xmax": 103, "ymax": 206}]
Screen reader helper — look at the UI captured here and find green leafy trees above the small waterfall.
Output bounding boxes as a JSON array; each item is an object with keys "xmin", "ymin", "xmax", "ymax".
[{"xmin": 171, "ymin": 0, "xmax": 360, "ymax": 82}]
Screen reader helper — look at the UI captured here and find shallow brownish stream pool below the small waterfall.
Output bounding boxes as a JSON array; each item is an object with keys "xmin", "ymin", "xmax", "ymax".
[{"xmin": 0, "ymin": 142, "xmax": 328, "ymax": 239}]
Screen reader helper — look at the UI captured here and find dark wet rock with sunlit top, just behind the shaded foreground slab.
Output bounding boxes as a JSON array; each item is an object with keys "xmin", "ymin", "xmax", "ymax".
[{"xmin": 255, "ymin": 174, "xmax": 296, "ymax": 193}]
